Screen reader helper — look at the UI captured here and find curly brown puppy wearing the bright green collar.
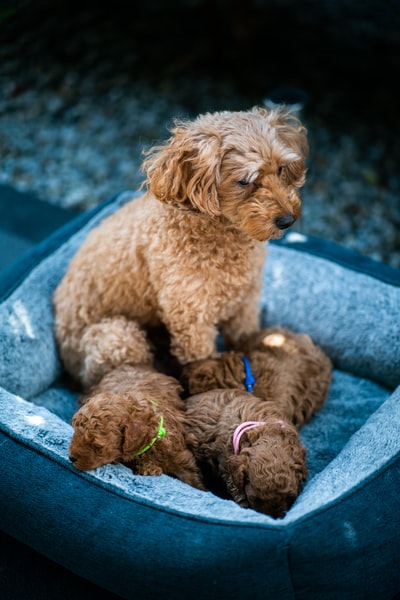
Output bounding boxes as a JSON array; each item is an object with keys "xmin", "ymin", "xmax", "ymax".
[{"xmin": 69, "ymin": 365, "xmax": 204, "ymax": 489}]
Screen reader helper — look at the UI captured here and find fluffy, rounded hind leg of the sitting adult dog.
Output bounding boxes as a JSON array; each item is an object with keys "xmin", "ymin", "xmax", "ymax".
[{"xmin": 79, "ymin": 316, "xmax": 153, "ymax": 388}]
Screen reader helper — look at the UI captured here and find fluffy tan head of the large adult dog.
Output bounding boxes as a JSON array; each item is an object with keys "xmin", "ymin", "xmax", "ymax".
[{"xmin": 143, "ymin": 107, "xmax": 308, "ymax": 241}]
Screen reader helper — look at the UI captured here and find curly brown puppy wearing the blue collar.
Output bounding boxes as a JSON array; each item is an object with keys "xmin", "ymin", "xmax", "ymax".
[{"xmin": 181, "ymin": 327, "xmax": 332, "ymax": 427}]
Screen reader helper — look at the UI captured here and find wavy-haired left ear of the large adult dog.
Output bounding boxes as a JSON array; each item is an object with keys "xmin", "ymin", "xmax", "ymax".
[{"xmin": 142, "ymin": 122, "xmax": 221, "ymax": 216}]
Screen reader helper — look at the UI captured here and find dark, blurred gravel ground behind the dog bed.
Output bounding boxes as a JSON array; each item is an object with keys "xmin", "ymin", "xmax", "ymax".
[{"xmin": 0, "ymin": 0, "xmax": 400, "ymax": 268}]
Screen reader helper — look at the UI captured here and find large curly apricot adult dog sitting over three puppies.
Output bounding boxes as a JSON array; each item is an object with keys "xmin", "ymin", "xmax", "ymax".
[{"xmin": 54, "ymin": 107, "xmax": 308, "ymax": 388}]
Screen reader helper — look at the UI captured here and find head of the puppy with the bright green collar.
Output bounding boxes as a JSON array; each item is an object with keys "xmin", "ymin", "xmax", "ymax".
[{"xmin": 69, "ymin": 394, "xmax": 159, "ymax": 471}]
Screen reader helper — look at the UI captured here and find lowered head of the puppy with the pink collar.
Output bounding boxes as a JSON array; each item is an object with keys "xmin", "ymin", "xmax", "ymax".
[{"xmin": 226, "ymin": 419, "xmax": 307, "ymax": 518}]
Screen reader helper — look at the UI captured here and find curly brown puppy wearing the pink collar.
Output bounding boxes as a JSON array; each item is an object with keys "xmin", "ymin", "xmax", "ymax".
[{"xmin": 186, "ymin": 389, "xmax": 307, "ymax": 518}]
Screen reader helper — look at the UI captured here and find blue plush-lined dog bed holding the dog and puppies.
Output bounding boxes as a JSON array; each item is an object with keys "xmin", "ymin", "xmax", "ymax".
[{"xmin": 0, "ymin": 192, "xmax": 400, "ymax": 600}]
